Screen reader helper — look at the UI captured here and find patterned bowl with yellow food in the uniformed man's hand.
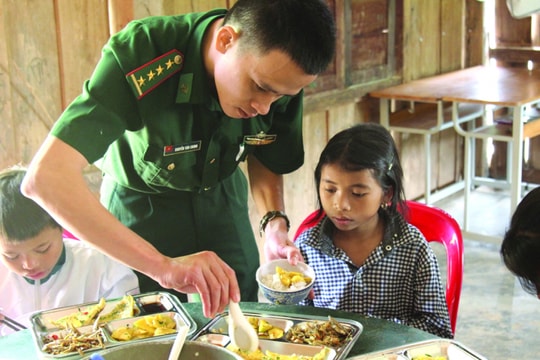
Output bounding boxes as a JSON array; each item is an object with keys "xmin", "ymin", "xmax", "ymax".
[{"xmin": 255, "ymin": 259, "xmax": 315, "ymax": 305}]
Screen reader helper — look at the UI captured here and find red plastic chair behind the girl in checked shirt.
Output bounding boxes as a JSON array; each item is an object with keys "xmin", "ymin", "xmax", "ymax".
[{"xmin": 294, "ymin": 201, "xmax": 463, "ymax": 334}]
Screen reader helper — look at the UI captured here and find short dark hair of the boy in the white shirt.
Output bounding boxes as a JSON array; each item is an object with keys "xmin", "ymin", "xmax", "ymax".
[{"xmin": 0, "ymin": 166, "xmax": 61, "ymax": 241}]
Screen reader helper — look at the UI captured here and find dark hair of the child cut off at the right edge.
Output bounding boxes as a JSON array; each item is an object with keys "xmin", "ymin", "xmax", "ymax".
[{"xmin": 501, "ymin": 188, "xmax": 540, "ymax": 295}]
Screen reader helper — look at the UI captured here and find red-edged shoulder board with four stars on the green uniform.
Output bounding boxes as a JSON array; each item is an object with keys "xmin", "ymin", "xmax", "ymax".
[{"xmin": 126, "ymin": 49, "xmax": 184, "ymax": 99}]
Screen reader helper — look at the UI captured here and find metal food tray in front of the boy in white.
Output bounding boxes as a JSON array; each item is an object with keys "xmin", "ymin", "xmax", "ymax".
[{"xmin": 31, "ymin": 292, "xmax": 197, "ymax": 360}]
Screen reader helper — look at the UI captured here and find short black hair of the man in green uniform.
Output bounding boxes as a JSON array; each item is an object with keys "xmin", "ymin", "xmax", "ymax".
[{"xmin": 223, "ymin": 0, "xmax": 336, "ymax": 75}]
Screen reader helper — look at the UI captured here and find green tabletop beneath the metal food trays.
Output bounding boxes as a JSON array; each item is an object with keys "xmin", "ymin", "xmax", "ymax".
[{"xmin": 0, "ymin": 302, "xmax": 439, "ymax": 360}]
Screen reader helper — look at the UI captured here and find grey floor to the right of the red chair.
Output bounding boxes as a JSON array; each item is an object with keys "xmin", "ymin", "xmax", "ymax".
[{"xmin": 435, "ymin": 189, "xmax": 540, "ymax": 360}]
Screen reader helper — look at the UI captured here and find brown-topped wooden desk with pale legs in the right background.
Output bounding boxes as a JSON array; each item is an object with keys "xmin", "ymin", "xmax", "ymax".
[{"xmin": 370, "ymin": 66, "xmax": 540, "ymax": 237}]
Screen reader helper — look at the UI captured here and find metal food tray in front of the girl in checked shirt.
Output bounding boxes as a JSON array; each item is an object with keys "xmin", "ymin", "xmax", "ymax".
[{"xmin": 193, "ymin": 312, "xmax": 363, "ymax": 360}]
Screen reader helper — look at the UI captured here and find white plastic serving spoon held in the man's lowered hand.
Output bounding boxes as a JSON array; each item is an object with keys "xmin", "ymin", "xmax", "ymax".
[{"xmin": 229, "ymin": 301, "xmax": 259, "ymax": 352}]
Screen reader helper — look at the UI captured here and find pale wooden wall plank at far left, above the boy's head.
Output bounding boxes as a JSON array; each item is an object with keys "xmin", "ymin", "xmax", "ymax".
[{"xmin": 2, "ymin": 0, "xmax": 61, "ymax": 163}]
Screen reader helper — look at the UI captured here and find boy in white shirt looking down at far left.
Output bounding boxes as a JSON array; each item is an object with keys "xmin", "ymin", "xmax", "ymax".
[{"xmin": 0, "ymin": 167, "xmax": 139, "ymax": 333}]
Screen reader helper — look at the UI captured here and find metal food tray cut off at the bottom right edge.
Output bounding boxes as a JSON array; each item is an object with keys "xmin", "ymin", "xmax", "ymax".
[{"xmin": 349, "ymin": 339, "xmax": 487, "ymax": 360}]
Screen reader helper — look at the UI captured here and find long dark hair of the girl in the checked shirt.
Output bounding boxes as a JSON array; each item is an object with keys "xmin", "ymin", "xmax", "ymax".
[{"xmin": 315, "ymin": 123, "xmax": 406, "ymax": 220}]
